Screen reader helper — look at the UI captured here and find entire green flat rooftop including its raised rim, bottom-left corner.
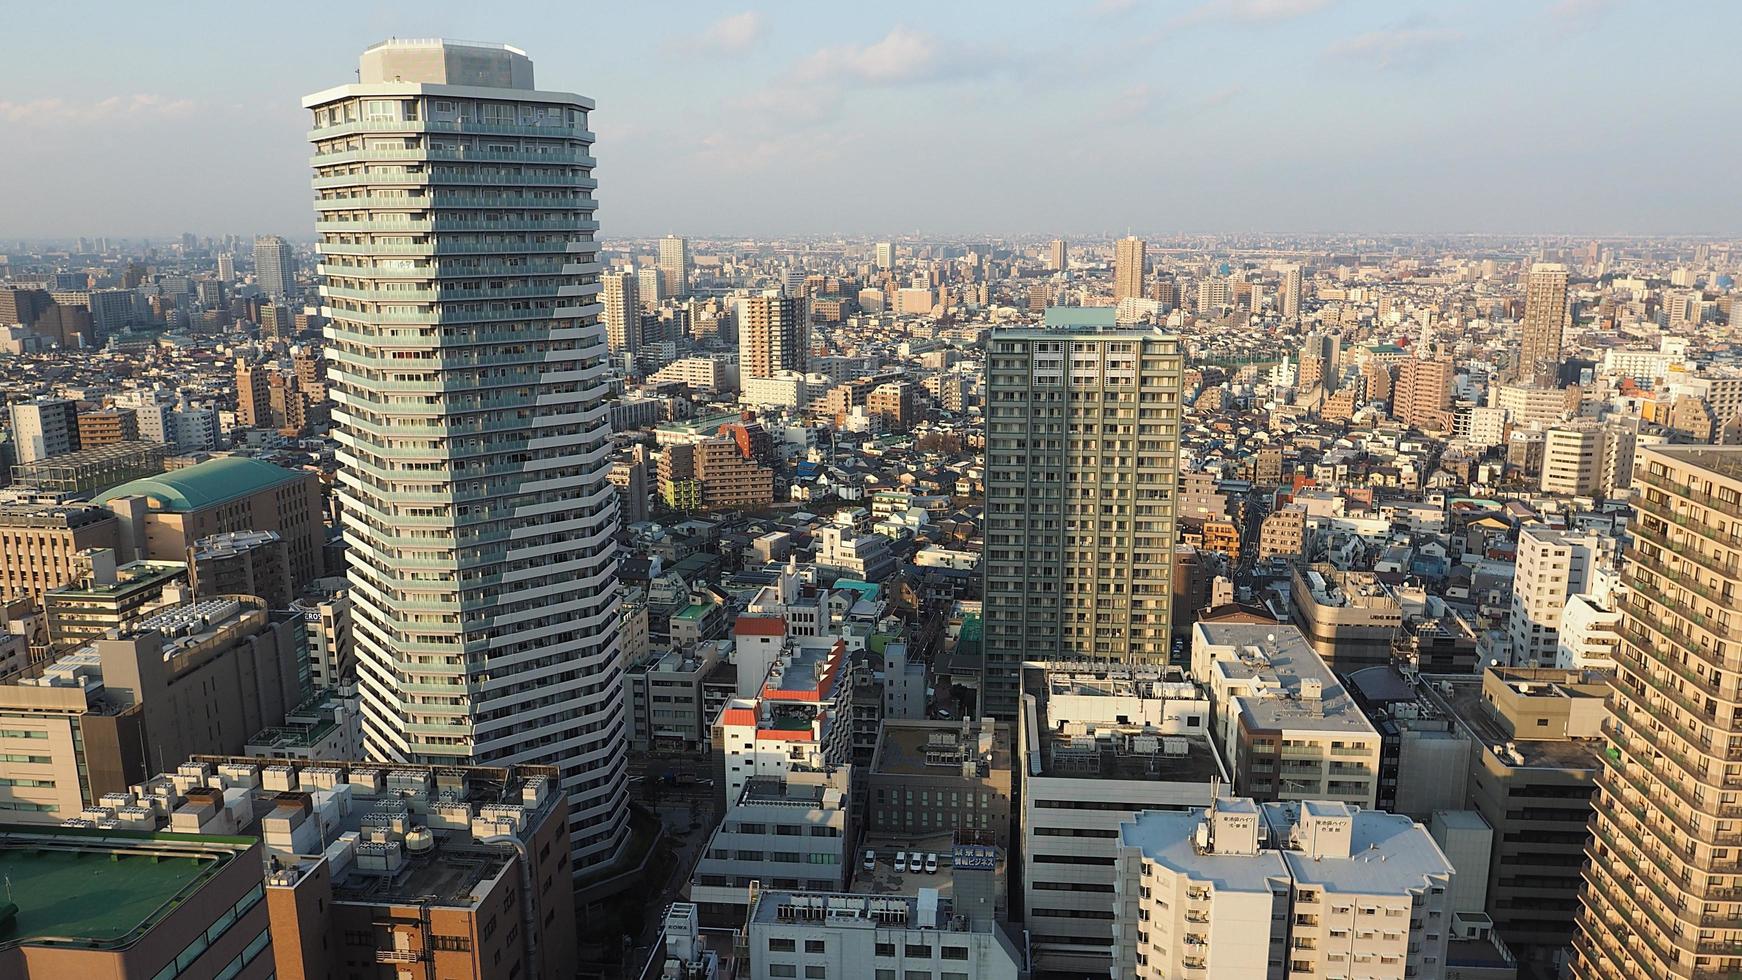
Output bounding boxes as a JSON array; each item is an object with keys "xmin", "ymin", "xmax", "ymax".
[{"xmin": 0, "ymin": 825, "xmax": 251, "ymax": 949}]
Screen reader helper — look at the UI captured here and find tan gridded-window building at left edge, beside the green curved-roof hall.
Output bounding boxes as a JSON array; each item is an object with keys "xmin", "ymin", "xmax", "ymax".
[{"xmin": 0, "ymin": 503, "xmax": 120, "ymax": 607}]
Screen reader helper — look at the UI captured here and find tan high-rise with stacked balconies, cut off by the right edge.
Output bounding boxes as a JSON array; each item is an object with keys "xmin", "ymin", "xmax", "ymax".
[{"xmin": 1573, "ymin": 446, "xmax": 1742, "ymax": 980}]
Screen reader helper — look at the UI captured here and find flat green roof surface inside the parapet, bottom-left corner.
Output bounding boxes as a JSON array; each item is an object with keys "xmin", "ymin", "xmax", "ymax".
[{"xmin": 0, "ymin": 842, "xmax": 221, "ymax": 945}]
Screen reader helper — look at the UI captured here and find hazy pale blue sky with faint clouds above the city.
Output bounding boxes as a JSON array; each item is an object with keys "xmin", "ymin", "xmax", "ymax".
[{"xmin": 0, "ymin": 0, "xmax": 1742, "ymax": 240}]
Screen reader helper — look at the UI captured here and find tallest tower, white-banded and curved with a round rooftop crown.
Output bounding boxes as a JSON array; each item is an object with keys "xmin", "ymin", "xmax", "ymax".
[{"xmin": 303, "ymin": 40, "xmax": 629, "ymax": 876}]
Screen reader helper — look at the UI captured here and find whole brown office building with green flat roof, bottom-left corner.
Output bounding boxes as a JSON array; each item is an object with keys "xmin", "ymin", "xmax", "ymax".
[{"xmin": 0, "ymin": 825, "xmax": 271, "ymax": 980}]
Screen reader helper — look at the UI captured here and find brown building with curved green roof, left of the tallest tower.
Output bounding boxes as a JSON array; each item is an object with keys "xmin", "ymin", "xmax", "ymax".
[{"xmin": 94, "ymin": 456, "xmax": 326, "ymax": 588}]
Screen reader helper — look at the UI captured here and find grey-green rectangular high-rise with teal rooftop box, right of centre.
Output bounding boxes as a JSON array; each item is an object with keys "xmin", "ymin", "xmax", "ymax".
[{"xmin": 982, "ymin": 308, "xmax": 1183, "ymax": 717}]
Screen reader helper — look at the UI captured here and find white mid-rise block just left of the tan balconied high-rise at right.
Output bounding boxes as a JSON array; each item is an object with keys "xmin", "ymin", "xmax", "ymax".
[{"xmin": 1507, "ymin": 524, "xmax": 1601, "ymax": 667}]
